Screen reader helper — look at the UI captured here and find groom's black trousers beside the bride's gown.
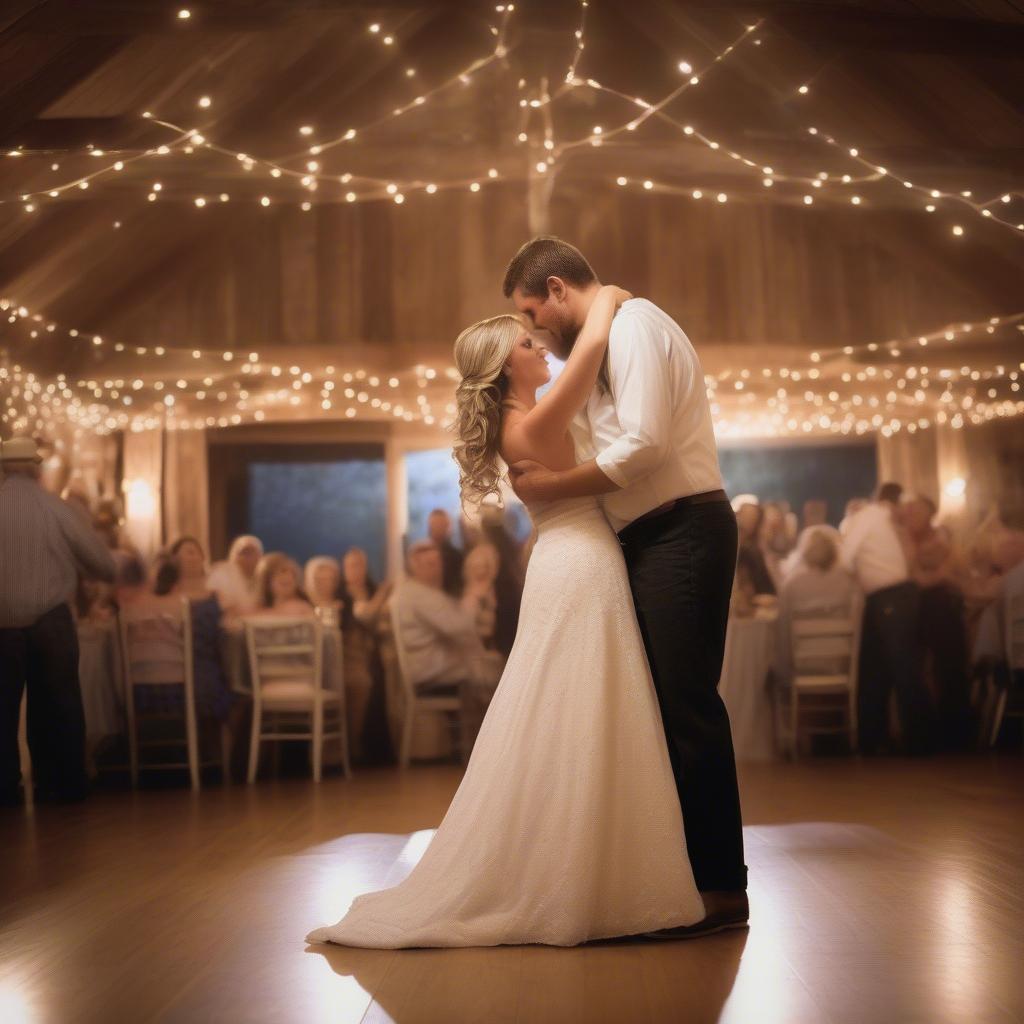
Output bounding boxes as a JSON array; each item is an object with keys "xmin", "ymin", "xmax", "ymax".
[{"xmin": 620, "ymin": 500, "xmax": 746, "ymax": 892}]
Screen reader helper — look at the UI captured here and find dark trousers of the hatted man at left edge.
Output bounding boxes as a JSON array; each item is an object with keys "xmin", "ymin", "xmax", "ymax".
[{"xmin": 0, "ymin": 604, "xmax": 89, "ymax": 800}]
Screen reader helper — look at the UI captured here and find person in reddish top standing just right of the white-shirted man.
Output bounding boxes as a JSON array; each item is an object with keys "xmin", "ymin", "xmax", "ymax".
[{"xmin": 900, "ymin": 496, "xmax": 974, "ymax": 750}]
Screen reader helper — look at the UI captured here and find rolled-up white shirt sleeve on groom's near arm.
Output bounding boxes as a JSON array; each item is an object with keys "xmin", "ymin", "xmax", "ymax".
[{"xmin": 597, "ymin": 313, "xmax": 673, "ymax": 487}]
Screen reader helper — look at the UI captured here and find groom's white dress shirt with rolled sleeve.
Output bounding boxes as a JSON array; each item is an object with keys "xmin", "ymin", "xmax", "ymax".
[{"xmin": 572, "ymin": 299, "xmax": 722, "ymax": 531}]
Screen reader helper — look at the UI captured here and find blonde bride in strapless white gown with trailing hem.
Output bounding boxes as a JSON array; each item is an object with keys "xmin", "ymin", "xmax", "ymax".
[{"xmin": 307, "ymin": 286, "xmax": 703, "ymax": 948}]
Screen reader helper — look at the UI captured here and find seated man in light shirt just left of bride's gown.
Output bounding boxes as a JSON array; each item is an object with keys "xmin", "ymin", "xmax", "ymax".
[{"xmin": 394, "ymin": 541, "xmax": 501, "ymax": 756}]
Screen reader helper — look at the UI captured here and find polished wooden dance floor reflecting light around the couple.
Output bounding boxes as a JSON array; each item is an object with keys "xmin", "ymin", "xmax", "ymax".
[{"xmin": 0, "ymin": 758, "xmax": 1024, "ymax": 1024}]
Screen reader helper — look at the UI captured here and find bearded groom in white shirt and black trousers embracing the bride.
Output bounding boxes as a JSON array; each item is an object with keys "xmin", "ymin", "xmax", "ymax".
[{"xmin": 503, "ymin": 238, "xmax": 749, "ymax": 938}]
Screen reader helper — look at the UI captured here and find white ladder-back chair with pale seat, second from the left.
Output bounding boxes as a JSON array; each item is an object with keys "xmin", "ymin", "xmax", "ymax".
[{"xmin": 245, "ymin": 617, "xmax": 352, "ymax": 782}]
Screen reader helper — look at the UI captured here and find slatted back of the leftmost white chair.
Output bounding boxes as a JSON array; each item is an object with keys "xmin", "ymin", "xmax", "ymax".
[{"xmin": 118, "ymin": 597, "xmax": 195, "ymax": 695}]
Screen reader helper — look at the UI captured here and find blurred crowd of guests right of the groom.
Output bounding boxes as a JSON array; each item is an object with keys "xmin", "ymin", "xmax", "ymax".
[{"xmin": 732, "ymin": 482, "xmax": 1024, "ymax": 754}]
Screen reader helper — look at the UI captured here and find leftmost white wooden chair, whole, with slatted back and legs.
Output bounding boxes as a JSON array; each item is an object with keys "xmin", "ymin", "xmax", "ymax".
[{"xmin": 118, "ymin": 597, "xmax": 228, "ymax": 790}]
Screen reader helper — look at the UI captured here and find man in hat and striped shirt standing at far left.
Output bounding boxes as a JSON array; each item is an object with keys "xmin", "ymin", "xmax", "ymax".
[{"xmin": 0, "ymin": 437, "xmax": 115, "ymax": 804}]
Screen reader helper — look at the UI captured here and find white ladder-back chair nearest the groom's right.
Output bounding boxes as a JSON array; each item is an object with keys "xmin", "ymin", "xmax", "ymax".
[{"xmin": 783, "ymin": 617, "xmax": 860, "ymax": 758}]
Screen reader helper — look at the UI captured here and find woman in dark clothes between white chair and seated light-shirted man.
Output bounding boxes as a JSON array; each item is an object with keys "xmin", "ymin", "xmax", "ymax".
[{"xmin": 337, "ymin": 548, "xmax": 392, "ymax": 763}]
